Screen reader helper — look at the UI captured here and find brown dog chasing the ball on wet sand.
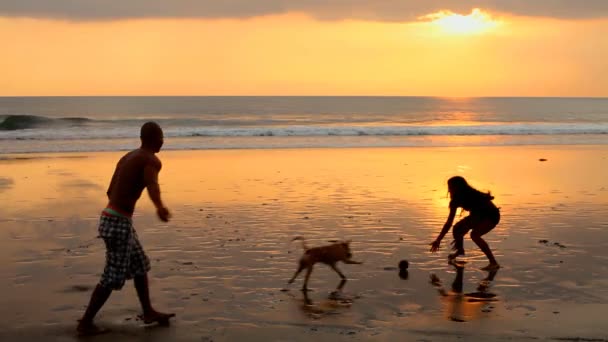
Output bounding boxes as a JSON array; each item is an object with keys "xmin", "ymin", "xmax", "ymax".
[{"xmin": 288, "ymin": 236, "xmax": 362, "ymax": 291}]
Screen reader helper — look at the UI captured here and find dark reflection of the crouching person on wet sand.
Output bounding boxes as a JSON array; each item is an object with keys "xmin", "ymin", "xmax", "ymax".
[{"xmin": 430, "ymin": 263, "xmax": 498, "ymax": 322}]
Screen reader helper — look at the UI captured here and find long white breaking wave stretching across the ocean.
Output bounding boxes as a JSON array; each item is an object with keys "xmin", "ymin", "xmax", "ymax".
[{"xmin": 0, "ymin": 123, "xmax": 608, "ymax": 140}]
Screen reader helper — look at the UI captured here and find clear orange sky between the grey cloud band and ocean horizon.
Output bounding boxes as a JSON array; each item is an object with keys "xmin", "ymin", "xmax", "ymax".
[{"xmin": 0, "ymin": 13, "xmax": 608, "ymax": 96}]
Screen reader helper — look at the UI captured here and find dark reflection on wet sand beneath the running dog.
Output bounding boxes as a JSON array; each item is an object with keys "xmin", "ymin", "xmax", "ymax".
[{"xmin": 288, "ymin": 280, "xmax": 356, "ymax": 319}]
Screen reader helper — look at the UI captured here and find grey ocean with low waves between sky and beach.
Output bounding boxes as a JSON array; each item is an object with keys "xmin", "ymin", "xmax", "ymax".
[{"xmin": 0, "ymin": 96, "xmax": 608, "ymax": 154}]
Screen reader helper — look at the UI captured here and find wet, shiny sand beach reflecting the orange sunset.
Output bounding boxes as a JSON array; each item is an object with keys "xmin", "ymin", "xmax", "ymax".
[{"xmin": 0, "ymin": 146, "xmax": 608, "ymax": 341}]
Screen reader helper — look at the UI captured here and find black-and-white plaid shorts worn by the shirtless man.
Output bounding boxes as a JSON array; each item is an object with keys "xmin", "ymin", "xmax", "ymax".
[{"xmin": 99, "ymin": 215, "xmax": 150, "ymax": 290}]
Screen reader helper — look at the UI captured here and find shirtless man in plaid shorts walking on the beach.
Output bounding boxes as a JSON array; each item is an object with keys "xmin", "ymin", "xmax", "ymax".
[{"xmin": 77, "ymin": 122, "xmax": 175, "ymax": 335}]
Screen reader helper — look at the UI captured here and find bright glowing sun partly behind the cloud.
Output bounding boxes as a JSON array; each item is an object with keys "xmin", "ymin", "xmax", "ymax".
[{"xmin": 420, "ymin": 8, "xmax": 499, "ymax": 35}]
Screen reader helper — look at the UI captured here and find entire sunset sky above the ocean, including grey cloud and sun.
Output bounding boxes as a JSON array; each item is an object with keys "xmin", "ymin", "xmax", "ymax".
[{"xmin": 0, "ymin": 0, "xmax": 608, "ymax": 96}]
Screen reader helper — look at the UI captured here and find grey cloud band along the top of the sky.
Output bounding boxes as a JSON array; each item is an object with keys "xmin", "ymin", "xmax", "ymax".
[{"xmin": 0, "ymin": 0, "xmax": 608, "ymax": 22}]
